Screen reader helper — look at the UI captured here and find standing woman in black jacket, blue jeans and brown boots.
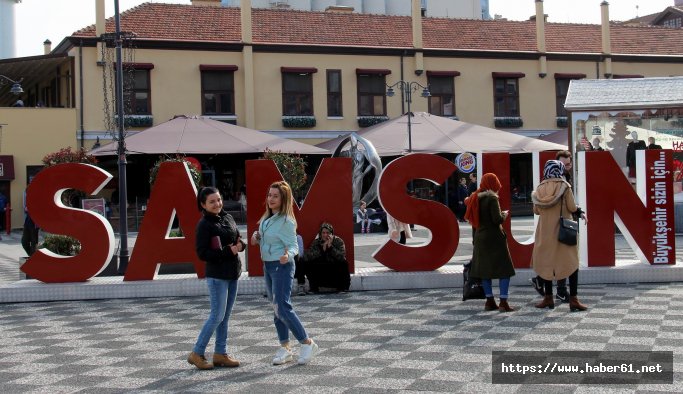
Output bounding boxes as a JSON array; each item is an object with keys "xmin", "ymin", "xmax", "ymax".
[{"xmin": 187, "ymin": 187, "xmax": 245, "ymax": 369}]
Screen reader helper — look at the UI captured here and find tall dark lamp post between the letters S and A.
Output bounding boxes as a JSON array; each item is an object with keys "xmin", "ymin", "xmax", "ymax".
[{"xmin": 114, "ymin": 0, "xmax": 128, "ymax": 274}]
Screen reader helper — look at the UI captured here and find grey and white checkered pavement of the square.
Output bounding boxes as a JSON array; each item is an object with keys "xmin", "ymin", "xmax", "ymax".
[{"xmin": 0, "ymin": 283, "xmax": 683, "ymax": 394}]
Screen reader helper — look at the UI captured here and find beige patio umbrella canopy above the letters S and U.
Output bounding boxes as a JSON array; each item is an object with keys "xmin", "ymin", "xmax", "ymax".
[{"xmin": 316, "ymin": 112, "xmax": 567, "ymax": 156}]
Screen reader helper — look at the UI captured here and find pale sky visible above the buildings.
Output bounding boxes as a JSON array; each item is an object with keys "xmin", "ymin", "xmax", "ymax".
[{"xmin": 8, "ymin": 0, "xmax": 674, "ymax": 57}]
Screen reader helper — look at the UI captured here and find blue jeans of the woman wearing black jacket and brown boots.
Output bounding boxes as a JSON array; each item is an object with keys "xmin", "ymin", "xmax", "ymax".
[{"xmin": 193, "ymin": 278, "xmax": 237, "ymax": 356}]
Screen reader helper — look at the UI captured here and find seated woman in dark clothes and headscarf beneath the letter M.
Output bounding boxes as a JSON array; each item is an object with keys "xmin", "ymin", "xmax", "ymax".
[{"xmin": 303, "ymin": 223, "xmax": 351, "ymax": 293}]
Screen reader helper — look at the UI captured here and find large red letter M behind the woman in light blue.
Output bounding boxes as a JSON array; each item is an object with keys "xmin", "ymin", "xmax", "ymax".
[{"xmin": 246, "ymin": 158, "xmax": 355, "ymax": 276}]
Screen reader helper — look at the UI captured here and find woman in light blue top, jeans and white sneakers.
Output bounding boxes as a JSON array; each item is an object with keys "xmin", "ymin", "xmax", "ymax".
[{"xmin": 251, "ymin": 181, "xmax": 318, "ymax": 365}]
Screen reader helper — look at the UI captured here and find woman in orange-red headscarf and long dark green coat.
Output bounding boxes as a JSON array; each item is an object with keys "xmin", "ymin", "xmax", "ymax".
[{"xmin": 465, "ymin": 173, "xmax": 515, "ymax": 312}]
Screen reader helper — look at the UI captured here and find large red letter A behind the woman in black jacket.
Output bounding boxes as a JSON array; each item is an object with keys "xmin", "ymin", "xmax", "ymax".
[{"xmin": 123, "ymin": 162, "xmax": 204, "ymax": 281}]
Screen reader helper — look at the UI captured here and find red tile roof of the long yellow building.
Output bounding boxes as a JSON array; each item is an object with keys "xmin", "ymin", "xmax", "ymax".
[{"xmin": 73, "ymin": 3, "xmax": 683, "ymax": 55}]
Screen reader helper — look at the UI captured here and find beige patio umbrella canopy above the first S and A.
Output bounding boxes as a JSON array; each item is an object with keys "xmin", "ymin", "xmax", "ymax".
[{"xmin": 90, "ymin": 116, "xmax": 330, "ymax": 156}]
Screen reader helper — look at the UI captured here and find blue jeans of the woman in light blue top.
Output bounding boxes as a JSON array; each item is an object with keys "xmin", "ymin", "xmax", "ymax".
[{"xmin": 263, "ymin": 261, "xmax": 308, "ymax": 344}]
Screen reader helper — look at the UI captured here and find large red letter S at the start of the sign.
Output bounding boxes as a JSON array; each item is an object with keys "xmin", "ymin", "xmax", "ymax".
[{"xmin": 21, "ymin": 163, "xmax": 114, "ymax": 283}]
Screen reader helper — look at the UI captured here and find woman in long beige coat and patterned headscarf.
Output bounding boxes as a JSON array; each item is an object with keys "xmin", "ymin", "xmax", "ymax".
[{"xmin": 531, "ymin": 160, "xmax": 588, "ymax": 312}]
